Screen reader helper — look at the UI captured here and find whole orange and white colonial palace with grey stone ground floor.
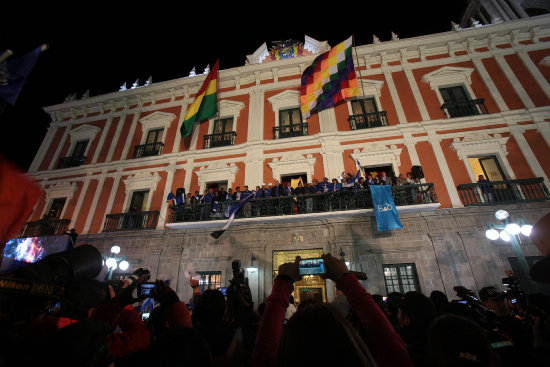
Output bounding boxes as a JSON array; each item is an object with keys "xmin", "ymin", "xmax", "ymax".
[{"xmin": 22, "ymin": 15, "xmax": 550, "ymax": 303}]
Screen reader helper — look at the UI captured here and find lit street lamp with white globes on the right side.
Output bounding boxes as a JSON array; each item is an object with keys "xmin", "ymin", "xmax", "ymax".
[{"xmin": 485, "ymin": 210, "xmax": 533, "ymax": 284}]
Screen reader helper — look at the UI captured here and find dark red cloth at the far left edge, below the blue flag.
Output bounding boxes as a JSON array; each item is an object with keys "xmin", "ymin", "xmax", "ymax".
[{"xmin": 0, "ymin": 157, "xmax": 42, "ymax": 252}]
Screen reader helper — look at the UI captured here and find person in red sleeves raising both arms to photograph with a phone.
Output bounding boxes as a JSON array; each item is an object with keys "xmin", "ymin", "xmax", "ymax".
[{"xmin": 252, "ymin": 254, "xmax": 413, "ymax": 366}]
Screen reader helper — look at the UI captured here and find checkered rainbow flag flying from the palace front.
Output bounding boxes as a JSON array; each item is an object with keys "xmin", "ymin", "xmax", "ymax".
[{"xmin": 300, "ymin": 37, "xmax": 359, "ymax": 120}]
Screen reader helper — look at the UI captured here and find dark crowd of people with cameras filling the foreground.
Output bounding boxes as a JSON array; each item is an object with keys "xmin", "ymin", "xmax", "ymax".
[{"xmin": 0, "ymin": 254, "xmax": 550, "ymax": 367}]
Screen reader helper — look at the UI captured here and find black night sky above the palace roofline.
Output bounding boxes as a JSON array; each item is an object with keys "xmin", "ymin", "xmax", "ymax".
[{"xmin": 0, "ymin": 0, "xmax": 466, "ymax": 170}]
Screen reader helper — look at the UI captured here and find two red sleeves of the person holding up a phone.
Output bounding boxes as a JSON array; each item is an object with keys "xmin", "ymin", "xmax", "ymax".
[{"xmin": 252, "ymin": 274, "xmax": 414, "ymax": 367}]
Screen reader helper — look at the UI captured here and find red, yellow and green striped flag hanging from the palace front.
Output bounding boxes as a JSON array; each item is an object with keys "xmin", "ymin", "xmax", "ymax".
[{"xmin": 180, "ymin": 61, "xmax": 218, "ymax": 138}]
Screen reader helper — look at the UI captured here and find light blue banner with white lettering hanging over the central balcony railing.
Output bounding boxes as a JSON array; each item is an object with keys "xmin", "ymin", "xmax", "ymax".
[{"xmin": 369, "ymin": 185, "xmax": 403, "ymax": 231}]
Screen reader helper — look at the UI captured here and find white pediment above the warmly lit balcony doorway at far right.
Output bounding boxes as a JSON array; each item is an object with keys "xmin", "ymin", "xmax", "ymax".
[{"xmin": 451, "ymin": 132, "xmax": 508, "ymax": 160}]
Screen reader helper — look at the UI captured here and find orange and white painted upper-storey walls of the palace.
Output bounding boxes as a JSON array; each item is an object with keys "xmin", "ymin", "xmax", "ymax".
[{"xmin": 23, "ymin": 16, "xmax": 550, "ymax": 302}]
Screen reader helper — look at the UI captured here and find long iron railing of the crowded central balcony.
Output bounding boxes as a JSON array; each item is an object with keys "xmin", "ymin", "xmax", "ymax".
[{"xmin": 168, "ymin": 183, "xmax": 437, "ymax": 223}]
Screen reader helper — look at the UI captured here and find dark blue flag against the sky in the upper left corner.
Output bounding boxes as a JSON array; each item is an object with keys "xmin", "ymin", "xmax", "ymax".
[{"xmin": 0, "ymin": 47, "xmax": 42, "ymax": 106}]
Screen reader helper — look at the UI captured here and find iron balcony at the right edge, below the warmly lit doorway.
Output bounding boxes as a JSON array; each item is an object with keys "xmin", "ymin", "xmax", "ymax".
[{"xmin": 457, "ymin": 177, "xmax": 550, "ymax": 206}]
